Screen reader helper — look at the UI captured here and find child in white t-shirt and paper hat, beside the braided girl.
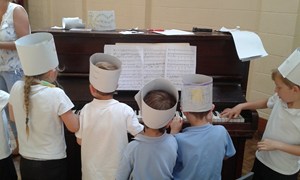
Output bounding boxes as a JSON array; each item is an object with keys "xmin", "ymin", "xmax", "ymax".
[{"xmin": 75, "ymin": 53, "xmax": 143, "ymax": 180}]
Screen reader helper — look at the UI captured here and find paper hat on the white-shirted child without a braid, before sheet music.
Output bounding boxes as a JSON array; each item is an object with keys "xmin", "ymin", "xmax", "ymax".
[{"xmin": 90, "ymin": 53, "xmax": 122, "ymax": 93}]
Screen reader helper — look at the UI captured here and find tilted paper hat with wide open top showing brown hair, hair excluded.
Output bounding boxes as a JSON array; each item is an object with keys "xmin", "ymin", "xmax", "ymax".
[{"xmin": 134, "ymin": 78, "xmax": 178, "ymax": 129}]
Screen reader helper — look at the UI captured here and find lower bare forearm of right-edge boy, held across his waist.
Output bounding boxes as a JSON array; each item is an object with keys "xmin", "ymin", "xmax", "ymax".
[{"xmin": 257, "ymin": 139, "xmax": 300, "ymax": 156}]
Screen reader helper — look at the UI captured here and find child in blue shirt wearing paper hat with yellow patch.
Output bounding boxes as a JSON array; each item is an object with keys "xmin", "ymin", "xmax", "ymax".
[{"xmin": 171, "ymin": 74, "xmax": 235, "ymax": 180}]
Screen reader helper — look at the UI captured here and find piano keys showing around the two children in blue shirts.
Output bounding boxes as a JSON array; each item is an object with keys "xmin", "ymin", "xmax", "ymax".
[{"xmin": 135, "ymin": 110, "xmax": 245, "ymax": 123}]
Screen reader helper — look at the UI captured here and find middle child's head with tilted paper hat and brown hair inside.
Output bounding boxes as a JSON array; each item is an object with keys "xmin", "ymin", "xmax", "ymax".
[{"xmin": 135, "ymin": 78, "xmax": 178, "ymax": 129}]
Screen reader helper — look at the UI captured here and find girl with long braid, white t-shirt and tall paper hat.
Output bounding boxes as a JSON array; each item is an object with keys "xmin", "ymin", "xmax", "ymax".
[{"xmin": 9, "ymin": 33, "xmax": 79, "ymax": 180}]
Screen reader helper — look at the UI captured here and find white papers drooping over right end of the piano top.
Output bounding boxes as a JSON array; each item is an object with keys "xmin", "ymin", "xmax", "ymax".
[{"xmin": 220, "ymin": 27, "xmax": 268, "ymax": 61}]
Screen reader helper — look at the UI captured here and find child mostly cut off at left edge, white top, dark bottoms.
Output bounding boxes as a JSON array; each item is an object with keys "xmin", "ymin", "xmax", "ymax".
[{"xmin": 0, "ymin": 90, "xmax": 18, "ymax": 180}]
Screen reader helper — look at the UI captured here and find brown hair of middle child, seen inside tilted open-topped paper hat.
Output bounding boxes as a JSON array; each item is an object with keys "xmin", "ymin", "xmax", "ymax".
[{"xmin": 144, "ymin": 90, "xmax": 176, "ymax": 133}]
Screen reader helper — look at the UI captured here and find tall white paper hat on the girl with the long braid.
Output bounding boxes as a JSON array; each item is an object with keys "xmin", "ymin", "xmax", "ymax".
[{"xmin": 15, "ymin": 33, "xmax": 58, "ymax": 76}]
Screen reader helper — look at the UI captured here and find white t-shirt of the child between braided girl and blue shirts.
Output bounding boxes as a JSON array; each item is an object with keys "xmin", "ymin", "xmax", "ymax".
[{"xmin": 75, "ymin": 99, "xmax": 143, "ymax": 180}]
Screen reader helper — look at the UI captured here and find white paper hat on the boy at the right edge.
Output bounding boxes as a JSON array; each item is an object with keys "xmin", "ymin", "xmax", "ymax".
[{"xmin": 278, "ymin": 48, "xmax": 300, "ymax": 86}]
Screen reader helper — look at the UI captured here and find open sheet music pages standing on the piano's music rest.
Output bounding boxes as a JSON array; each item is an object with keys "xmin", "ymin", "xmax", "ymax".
[{"xmin": 104, "ymin": 43, "xmax": 196, "ymax": 90}]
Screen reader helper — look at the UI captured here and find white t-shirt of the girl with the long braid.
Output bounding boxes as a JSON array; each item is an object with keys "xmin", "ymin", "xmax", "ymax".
[{"xmin": 9, "ymin": 81, "xmax": 74, "ymax": 160}]
